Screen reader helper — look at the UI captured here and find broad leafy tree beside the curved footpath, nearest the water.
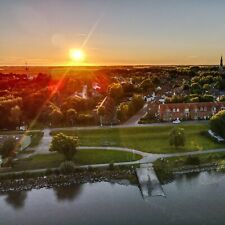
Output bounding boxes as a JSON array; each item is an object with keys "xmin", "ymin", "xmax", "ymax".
[{"xmin": 49, "ymin": 133, "xmax": 78, "ymax": 161}]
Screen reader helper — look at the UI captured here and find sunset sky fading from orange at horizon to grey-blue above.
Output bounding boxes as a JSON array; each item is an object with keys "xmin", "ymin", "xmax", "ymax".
[{"xmin": 0, "ymin": 0, "xmax": 225, "ymax": 65}]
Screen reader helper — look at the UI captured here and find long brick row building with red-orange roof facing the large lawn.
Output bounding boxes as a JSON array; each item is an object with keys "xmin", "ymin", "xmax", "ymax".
[{"xmin": 158, "ymin": 102, "xmax": 225, "ymax": 121}]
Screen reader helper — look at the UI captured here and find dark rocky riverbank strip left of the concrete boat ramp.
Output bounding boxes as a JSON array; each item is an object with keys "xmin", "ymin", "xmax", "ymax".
[{"xmin": 0, "ymin": 166, "xmax": 138, "ymax": 193}]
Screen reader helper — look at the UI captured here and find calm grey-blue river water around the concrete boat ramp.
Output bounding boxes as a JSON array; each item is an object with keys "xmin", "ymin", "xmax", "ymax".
[{"xmin": 0, "ymin": 172, "xmax": 225, "ymax": 225}]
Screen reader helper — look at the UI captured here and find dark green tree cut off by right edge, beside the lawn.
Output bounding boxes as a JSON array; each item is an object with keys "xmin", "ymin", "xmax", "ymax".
[{"xmin": 210, "ymin": 110, "xmax": 225, "ymax": 138}]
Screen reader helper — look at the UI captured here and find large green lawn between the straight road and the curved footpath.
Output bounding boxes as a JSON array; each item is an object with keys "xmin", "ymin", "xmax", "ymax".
[{"xmin": 53, "ymin": 123, "xmax": 225, "ymax": 153}]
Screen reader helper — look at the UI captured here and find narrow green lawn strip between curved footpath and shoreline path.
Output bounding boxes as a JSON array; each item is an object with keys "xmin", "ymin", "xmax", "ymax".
[{"xmin": 13, "ymin": 149, "xmax": 142, "ymax": 171}]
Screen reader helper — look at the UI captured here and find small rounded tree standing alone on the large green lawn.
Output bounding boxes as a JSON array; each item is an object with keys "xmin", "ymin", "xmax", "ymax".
[{"xmin": 169, "ymin": 128, "xmax": 185, "ymax": 148}]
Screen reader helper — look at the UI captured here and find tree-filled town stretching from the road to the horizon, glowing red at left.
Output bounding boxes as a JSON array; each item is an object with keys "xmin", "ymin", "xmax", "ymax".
[{"xmin": 0, "ymin": 57, "xmax": 225, "ymax": 130}]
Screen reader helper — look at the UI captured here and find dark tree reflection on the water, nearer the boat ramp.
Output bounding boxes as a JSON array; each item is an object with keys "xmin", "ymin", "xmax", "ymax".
[{"xmin": 53, "ymin": 184, "xmax": 82, "ymax": 201}]
